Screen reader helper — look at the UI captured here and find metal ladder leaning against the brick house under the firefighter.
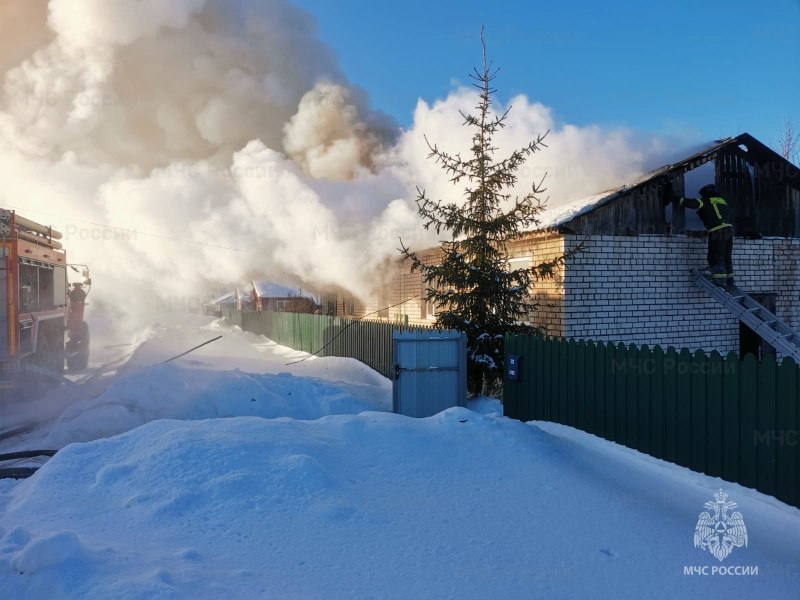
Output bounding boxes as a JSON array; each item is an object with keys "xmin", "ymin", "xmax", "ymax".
[{"xmin": 692, "ymin": 269, "xmax": 800, "ymax": 364}]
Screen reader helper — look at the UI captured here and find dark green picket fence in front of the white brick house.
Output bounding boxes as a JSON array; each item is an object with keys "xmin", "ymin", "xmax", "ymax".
[{"xmin": 503, "ymin": 336, "xmax": 800, "ymax": 507}]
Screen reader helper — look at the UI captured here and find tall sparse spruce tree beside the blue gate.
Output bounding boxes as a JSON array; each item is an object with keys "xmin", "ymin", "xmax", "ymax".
[{"xmin": 400, "ymin": 31, "xmax": 565, "ymax": 394}]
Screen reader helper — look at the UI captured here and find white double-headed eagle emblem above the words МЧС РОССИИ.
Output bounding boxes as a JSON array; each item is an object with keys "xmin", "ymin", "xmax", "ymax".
[{"xmin": 694, "ymin": 489, "xmax": 747, "ymax": 562}]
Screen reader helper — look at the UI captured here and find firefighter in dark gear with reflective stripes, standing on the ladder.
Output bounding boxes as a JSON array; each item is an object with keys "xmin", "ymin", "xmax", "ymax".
[{"xmin": 680, "ymin": 183, "xmax": 733, "ymax": 287}]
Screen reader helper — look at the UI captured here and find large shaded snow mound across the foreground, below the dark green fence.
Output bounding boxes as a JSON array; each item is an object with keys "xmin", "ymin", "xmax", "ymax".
[{"xmin": 0, "ymin": 408, "xmax": 800, "ymax": 598}]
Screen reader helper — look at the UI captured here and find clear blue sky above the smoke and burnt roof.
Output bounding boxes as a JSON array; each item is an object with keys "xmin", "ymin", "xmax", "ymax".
[{"xmin": 296, "ymin": 0, "xmax": 800, "ymax": 145}]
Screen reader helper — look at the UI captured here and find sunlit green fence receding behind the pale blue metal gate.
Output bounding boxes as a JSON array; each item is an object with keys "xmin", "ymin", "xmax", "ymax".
[{"xmin": 222, "ymin": 307, "xmax": 428, "ymax": 378}]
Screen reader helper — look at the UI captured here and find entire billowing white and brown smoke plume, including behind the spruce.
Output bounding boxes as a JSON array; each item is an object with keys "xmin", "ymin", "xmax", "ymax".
[{"xmin": 0, "ymin": 0, "xmax": 684, "ymax": 338}]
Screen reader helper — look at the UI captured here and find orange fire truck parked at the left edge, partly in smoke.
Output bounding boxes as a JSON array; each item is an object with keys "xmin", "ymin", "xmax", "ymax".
[{"xmin": 0, "ymin": 209, "xmax": 91, "ymax": 388}]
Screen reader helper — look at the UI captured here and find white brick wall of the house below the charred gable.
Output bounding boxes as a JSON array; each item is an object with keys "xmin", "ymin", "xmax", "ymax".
[{"xmin": 514, "ymin": 235, "xmax": 800, "ymax": 355}]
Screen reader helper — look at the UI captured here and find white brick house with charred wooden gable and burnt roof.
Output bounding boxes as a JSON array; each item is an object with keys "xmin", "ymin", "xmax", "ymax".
[{"xmin": 384, "ymin": 134, "xmax": 800, "ymax": 356}]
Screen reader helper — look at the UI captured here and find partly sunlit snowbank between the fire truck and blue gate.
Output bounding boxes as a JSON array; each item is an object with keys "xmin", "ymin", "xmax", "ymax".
[{"xmin": 0, "ymin": 315, "xmax": 392, "ymax": 451}]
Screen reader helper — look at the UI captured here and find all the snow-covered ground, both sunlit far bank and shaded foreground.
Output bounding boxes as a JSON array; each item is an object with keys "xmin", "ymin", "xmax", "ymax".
[{"xmin": 0, "ymin": 319, "xmax": 800, "ymax": 599}]
